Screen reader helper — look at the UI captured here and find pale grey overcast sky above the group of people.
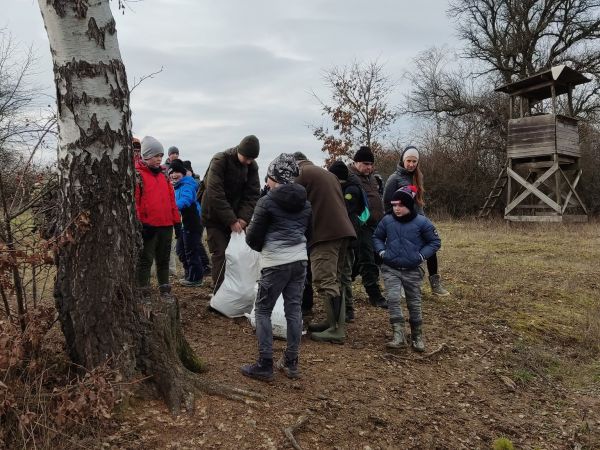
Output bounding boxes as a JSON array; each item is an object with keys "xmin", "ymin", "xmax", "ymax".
[{"xmin": 5, "ymin": 0, "xmax": 457, "ymax": 174}]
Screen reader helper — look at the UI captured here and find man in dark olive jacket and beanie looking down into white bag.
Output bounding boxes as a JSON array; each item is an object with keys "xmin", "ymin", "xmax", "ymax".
[{"xmin": 200, "ymin": 135, "xmax": 260, "ymax": 292}]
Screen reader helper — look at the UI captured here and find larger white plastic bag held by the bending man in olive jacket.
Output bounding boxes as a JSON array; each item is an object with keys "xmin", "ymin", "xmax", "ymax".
[{"xmin": 210, "ymin": 232, "xmax": 260, "ymax": 318}]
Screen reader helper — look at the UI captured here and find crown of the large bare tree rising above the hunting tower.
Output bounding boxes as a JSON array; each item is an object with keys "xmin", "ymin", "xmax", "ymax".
[{"xmin": 448, "ymin": 0, "xmax": 600, "ymax": 118}]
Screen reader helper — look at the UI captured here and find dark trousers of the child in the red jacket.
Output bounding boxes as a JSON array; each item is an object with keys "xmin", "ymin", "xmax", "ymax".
[{"xmin": 136, "ymin": 227, "xmax": 173, "ymax": 287}]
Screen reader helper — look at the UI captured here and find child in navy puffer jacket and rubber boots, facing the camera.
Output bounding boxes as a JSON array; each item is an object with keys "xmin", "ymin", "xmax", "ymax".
[{"xmin": 373, "ymin": 185, "xmax": 441, "ymax": 352}]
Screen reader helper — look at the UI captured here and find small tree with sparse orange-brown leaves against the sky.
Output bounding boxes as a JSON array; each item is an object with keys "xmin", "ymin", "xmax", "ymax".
[{"xmin": 313, "ymin": 61, "xmax": 398, "ymax": 161}]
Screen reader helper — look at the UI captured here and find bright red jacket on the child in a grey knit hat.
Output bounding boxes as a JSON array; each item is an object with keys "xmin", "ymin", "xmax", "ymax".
[{"xmin": 135, "ymin": 160, "xmax": 181, "ymax": 227}]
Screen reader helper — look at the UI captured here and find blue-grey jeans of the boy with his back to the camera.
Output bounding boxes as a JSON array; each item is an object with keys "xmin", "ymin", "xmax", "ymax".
[{"xmin": 254, "ymin": 261, "xmax": 307, "ymax": 359}]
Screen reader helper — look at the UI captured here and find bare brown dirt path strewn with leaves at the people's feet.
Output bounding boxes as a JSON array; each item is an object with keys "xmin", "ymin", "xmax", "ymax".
[{"xmin": 105, "ymin": 222, "xmax": 600, "ymax": 449}]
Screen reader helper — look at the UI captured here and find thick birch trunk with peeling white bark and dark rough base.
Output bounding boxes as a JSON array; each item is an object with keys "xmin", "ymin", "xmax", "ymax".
[{"xmin": 39, "ymin": 0, "xmax": 216, "ymax": 412}]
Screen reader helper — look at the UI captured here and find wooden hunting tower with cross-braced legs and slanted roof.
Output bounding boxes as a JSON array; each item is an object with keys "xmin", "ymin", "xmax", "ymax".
[{"xmin": 482, "ymin": 65, "xmax": 590, "ymax": 222}]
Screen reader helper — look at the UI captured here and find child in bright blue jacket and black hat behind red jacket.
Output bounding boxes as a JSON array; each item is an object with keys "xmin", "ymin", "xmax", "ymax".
[{"xmin": 169, "ymin": 159, "xmax": 204, "ymax": 287}]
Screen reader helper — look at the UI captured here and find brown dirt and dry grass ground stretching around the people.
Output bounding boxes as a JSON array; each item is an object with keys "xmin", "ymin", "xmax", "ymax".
[{"xmin": 9, "ymin": 220, "xmax": 600, "ymax": 450}]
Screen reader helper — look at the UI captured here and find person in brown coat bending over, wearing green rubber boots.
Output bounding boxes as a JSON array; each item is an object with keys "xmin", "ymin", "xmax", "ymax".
[{"xmin": 294, "ymin": 152, "xmax": 356, "ymax": 344}]
